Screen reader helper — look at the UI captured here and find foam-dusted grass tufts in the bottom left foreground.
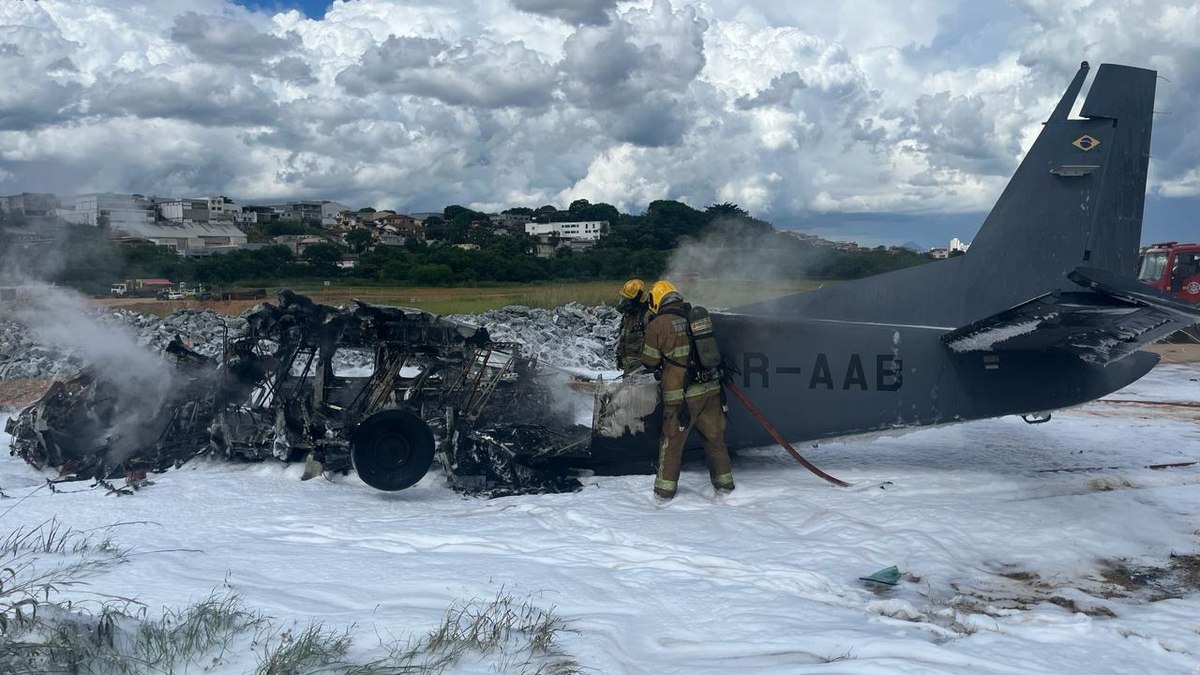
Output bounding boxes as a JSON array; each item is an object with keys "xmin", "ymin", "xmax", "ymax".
[{"xmin": 0, "ymin": 519, "xmax": 583, "ymax": 675}]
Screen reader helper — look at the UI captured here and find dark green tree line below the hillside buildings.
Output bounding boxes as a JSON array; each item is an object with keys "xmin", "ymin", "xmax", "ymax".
[{"xmin": 0, "ymin": 199, "xmax": 929, "ymax": 292}]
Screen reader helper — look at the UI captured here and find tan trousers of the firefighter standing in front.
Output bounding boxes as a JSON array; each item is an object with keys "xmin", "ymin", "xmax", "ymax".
[{"xmin": 654, "ymin": 390, "xmax": 733, "ymax": 497}]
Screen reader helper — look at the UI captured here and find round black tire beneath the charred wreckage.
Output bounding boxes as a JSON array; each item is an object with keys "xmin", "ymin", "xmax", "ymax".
[{"xmin": 350, "ymin": 410, "xmax": 434, "ymax": 491}]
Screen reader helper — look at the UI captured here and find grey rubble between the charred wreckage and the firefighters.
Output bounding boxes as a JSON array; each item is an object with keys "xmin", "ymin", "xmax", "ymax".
[{"xmin": 449, "ymin": 303, "xmax": 620, "ymax": 370}]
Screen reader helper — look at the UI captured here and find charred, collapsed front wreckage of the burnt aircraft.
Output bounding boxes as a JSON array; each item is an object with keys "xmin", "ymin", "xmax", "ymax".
[{"xmin": 6, "ymin": 291, "xmax": 659, "ymax": 496}]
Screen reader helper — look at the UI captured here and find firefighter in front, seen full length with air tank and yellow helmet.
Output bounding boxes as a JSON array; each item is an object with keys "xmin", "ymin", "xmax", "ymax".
[{"xmin": 642, "ymin": 281, "xmax": 733, "ymax": 502}]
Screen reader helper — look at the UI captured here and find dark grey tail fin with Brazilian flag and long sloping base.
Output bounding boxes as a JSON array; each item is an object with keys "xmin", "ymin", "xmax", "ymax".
[{"xmin": 737, "ymin": 62, "xmax": 1157, "ymax": 329}]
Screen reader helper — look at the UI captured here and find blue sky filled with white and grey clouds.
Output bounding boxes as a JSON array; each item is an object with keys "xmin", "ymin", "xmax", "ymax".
[{"xmin": 0, "ymin": 0, "xmax": 1200, "ymax": 246}]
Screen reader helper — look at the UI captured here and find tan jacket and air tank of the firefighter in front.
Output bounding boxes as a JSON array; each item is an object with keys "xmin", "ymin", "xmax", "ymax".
[{"xmin": 642, "ymin": 303, "xmax": 721, "ymax": 406}]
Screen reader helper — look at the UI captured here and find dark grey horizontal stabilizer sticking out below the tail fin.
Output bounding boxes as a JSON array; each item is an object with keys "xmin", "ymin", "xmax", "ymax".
[{"xmin": 942, "ymin": 268, "xmax": 1200, "ymax": 365}]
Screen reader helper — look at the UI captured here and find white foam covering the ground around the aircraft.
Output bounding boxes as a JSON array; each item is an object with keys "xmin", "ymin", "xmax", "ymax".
[{"xmin": 0, "ymin": 364, "xmax": 1200, "ymax": 674}]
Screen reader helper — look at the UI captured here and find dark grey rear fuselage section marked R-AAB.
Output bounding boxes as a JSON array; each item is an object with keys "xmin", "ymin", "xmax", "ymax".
[{"xmin": 715, "ymin": 315, "xmax": 1157, "ymax": 447}]
